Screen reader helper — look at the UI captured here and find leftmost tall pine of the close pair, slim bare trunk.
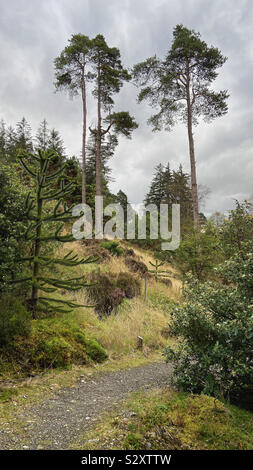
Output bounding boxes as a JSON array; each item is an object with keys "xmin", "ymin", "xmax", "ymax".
[{"xmin": 54, "ymin": 34, "xmax": 92, "ymax": 203}]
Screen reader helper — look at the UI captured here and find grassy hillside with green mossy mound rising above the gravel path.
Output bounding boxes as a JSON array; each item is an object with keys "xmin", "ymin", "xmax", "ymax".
[{"xmin": 0, "ymin": 242, "xmax": 180, "ymax": 380}]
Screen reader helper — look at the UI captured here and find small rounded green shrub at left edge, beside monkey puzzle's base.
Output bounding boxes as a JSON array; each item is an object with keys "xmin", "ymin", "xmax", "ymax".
[{"xmin": 0, "ymin": 297, "xmax": 31, "ymax": 348}]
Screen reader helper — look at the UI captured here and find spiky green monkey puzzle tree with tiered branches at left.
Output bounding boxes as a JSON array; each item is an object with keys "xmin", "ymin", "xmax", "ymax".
[{"xmin": 11, "ymin": 149, "xmax": 93, "ymax": 317}]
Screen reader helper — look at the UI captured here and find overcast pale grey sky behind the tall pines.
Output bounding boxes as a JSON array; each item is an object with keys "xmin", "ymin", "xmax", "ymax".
[{"xmin": 0, "ymin": 0, "xmax": 253, "ymax": 214}]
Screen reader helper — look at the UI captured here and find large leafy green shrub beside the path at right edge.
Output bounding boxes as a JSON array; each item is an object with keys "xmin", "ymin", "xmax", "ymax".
[{"xmin": 166, "ymin": 253, "xmax": 253, "ymax": 408}]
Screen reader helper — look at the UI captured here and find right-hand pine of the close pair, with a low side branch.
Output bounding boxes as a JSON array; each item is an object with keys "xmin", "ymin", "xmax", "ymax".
[{"xmin": 91, "ymin": 34, "xmax": 137, "ymax": 196}]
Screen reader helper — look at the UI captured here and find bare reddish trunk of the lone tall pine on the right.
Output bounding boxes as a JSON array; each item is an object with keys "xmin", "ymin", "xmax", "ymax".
[{"xmin": 186, "ymin": 59, "xmax": 199, "ymax": 228}]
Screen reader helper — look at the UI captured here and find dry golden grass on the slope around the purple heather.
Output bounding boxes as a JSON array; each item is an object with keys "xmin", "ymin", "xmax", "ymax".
[{"xmin": 49, "ymin": 241, "xmax": 181, "ymax": 358}]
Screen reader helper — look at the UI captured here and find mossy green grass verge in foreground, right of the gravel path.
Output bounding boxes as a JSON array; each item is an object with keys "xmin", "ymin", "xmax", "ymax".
[{"xmin": 73, "ymin": 388, "xmax": 253, "ymax": 450}]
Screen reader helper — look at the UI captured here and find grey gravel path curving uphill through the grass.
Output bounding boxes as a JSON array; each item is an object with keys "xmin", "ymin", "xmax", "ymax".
[{"xmin": 0, "ymin": 363, "xmax": 172, "ymax": 449}]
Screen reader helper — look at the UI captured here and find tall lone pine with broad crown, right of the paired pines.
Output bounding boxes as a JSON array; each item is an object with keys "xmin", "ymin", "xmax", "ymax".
[{"xmin": 133, "ymin": 25, "xmax": 228, "ymax": 227}]
